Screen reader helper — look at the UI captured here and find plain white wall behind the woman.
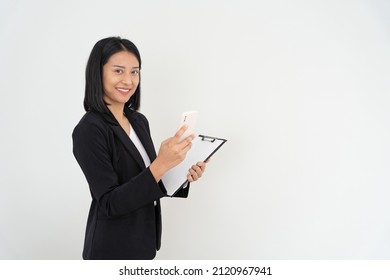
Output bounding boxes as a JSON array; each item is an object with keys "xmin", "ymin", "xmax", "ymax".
[{"xmin": 0, "ymin": 0, "xmax": 390, "ymax": 259}]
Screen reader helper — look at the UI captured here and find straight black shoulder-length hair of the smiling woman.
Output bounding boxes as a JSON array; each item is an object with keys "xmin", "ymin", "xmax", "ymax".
[{"xmin": 84, "ymin": 37, "xmax": 141, "ymax": 113}]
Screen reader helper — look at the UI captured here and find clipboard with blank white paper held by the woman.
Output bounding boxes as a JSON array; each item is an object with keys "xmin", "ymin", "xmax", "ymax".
[{"xmin": 161, "ymin": 135, "xmax": 227, "ymax": 197}]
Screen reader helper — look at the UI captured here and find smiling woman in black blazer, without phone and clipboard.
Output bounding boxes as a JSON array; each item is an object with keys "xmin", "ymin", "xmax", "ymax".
[{"xmin": 72, "ymin": 37, "xmax": 205, "ymax": 259}]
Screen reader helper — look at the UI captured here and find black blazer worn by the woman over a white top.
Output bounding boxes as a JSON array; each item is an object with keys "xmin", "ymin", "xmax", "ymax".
[{"xmin": 72, "ymin": 108, "xmax": 189, "ymax": 259}]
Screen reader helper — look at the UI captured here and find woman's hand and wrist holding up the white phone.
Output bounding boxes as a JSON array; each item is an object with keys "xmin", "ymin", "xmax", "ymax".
[{"xmin": 150, "ymin": 126, "xmax": 195, "ymax": 182}]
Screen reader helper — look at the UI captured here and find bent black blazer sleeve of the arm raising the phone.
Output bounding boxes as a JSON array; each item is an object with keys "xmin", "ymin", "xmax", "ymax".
[{"xmin": 72, "ymin": 120, "xmax": 166, "ymax": 216}]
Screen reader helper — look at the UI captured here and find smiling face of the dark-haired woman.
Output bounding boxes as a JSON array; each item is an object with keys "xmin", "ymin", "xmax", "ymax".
[{"xmin": 103, "ymin": 51, "xmax": 140, "ymax": 106}]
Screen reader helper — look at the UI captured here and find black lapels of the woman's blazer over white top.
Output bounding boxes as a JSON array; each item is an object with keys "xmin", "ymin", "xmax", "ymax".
[{"xmin": 99, "ymin": 107, "xmax": 156, "ymax": 169}]
